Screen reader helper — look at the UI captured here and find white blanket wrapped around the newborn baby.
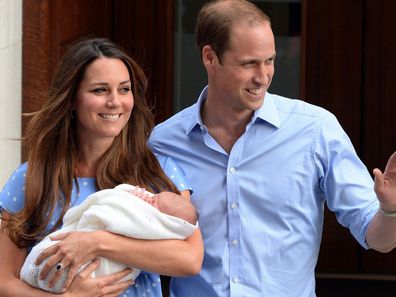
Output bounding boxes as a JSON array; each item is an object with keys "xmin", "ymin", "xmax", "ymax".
[{"xmin": 20, "ymin": 184, "xmax": 197, "ymax": 293}]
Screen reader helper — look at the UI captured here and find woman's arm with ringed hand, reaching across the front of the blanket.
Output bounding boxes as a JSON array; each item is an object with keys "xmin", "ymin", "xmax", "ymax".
[{"xmin": 37, "ymin": 193, "xmax": 203, "ymax": 290}]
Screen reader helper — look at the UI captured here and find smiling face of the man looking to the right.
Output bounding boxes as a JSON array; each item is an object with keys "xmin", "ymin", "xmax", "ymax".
[{"xmin": 206, "ymin": 22, "xmax": 275, "ymax": 112}]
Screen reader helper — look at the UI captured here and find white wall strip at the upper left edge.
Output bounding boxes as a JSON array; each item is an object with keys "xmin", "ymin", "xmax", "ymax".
[{"xmin": 0, "ymin": 0, "xmax": 22, "ymax": 189}]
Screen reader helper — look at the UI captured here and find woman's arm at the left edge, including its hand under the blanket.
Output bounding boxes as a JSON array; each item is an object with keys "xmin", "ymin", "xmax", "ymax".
[{"xmin": 0, "ymin": 212, "xmax": 131, "ymax": 297}]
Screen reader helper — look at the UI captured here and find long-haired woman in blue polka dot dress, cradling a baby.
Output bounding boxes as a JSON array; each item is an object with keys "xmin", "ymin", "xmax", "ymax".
[{"xmin": 0, "ymin": 39, "xmax": 203, "ymax": 296}]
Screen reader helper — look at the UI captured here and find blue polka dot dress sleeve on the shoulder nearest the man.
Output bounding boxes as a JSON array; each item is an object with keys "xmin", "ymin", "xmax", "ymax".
[{"xmin": 155, "ymin": 154, "xmax": 193, "ymax": 193}]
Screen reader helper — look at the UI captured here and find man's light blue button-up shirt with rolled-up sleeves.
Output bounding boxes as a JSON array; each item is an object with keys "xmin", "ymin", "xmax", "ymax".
[{"xmin": 149, "ymin": 89, "xmax": 379, "ymax": 297}]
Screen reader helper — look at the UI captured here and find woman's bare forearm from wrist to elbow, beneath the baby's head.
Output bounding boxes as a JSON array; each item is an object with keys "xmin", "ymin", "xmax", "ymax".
[{"xmin": 94, "ymin": 230, "xmax": 203, "ymax": 276}]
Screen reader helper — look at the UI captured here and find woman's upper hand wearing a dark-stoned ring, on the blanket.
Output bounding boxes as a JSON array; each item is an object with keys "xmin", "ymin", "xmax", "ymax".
[{"xmin": 36, "ymin": 232, "xmax": 97, "ymax": 288}]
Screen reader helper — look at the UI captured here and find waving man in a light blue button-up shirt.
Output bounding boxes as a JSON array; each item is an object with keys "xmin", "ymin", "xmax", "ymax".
[{"xmin": 150, "ymin": 0, "xmax": 396, "ymax": 297}]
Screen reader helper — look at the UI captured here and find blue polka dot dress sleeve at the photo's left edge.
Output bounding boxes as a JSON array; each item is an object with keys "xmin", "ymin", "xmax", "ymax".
[{"xmin": 0, "ymin": 163, "xmax": 27, "ymax": 213}]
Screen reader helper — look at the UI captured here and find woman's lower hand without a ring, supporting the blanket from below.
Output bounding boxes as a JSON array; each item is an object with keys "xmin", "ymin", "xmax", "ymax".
[{"xmin": 62, "ymin": 260, "xmax": 134, "ymax": 297}]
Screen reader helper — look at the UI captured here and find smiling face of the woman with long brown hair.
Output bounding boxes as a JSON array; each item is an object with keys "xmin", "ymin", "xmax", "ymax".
[{"xmin": 74, "ymin": 57, "xmax": 133, "ymax": 142}]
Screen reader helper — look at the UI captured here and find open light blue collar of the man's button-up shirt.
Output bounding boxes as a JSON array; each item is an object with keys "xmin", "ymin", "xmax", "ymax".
[{"xmin": 186, "ymin": 86, "xmax": 280, "ymax": 134}]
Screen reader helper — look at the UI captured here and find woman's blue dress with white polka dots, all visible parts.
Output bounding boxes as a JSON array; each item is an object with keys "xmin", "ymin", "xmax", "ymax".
[{"xmin": 0, "ymin": 155, "xmax": 191, "ymax": 297}]
